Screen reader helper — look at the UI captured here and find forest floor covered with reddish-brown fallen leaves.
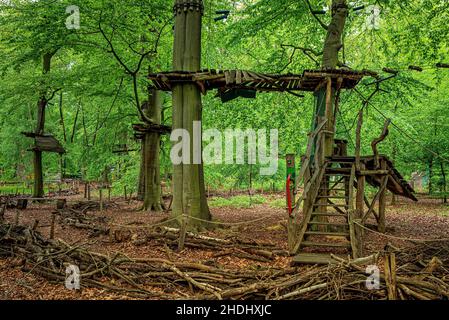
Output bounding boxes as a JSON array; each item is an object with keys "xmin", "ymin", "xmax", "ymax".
[{"xmin": 0, "ymin": 190, "xmax": 449, "ymax": 300}]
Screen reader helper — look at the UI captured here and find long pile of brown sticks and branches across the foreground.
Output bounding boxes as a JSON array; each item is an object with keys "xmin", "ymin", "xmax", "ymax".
[{"xmin": 0, "ymin": 224, "xmax": 449, "ymax": 300}]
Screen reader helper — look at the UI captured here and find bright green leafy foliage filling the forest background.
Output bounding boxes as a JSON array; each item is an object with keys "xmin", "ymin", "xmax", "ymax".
[{"xmin": 0, "ymin": 0, "xmax": 449, "ymax": 196}]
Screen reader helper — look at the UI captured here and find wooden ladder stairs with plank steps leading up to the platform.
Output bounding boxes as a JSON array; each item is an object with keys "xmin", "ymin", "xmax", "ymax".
[{"xmin": 293, "ymin": 160, "xmax": 358, "ymax": 264}]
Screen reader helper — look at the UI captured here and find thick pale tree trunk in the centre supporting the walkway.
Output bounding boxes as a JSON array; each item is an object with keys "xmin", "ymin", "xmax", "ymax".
[{"xmin": 173, "ymin": 0, "xmax": 211, "ymax": 227}]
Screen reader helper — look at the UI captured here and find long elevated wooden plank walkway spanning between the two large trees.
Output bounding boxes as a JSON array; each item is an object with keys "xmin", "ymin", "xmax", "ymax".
[{"xmin": 149, "ymin": 69, "xmax": 377, "ymax": 94}]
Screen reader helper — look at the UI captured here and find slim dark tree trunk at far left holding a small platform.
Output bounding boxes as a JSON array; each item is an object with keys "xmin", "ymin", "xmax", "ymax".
[{"xmin": 33, "ymin": 53, "xmax": 53, "ymax": 198}]
